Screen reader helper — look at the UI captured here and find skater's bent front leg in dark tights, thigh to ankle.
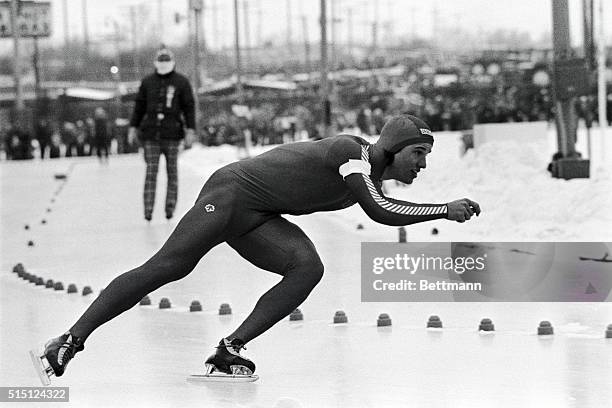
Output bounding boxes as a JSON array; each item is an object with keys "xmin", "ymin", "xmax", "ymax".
[{"xmin": 227, "ymin": 216, "xmax": 323, "ymax": 343}]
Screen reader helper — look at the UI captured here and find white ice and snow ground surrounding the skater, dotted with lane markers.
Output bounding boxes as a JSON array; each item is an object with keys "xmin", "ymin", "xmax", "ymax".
[{"xmin": 0, "ymin": 128, "xmax": 612, "ymax": 407}]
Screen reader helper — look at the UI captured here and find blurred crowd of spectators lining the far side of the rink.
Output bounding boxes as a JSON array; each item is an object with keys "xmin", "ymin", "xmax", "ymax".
[{"xmin": 4, "ymin": 52, "xmax": 612, "ymax": 159}]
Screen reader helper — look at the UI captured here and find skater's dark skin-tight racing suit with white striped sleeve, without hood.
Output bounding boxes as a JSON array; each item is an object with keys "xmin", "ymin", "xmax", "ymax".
[{"xmin": 70, "ymin": 135, "xmax": 447, "ymax": 343}]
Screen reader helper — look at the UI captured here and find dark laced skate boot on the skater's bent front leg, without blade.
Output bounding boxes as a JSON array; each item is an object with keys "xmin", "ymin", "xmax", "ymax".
[{"xmin": 204, "ymin": 338, "xmax": 255, "ymax": 376}]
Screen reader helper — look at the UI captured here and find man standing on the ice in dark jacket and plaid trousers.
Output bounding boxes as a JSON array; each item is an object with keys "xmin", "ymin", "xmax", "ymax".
[{"xmin": 128, "ymin": 48, "xmax": 195, "ymax": 221}]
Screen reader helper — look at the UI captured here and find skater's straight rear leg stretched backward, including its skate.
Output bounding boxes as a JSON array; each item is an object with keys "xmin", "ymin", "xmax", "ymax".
[{"xmin": 32, "ymin": 169, "xmax": 269, "ymax": 383}]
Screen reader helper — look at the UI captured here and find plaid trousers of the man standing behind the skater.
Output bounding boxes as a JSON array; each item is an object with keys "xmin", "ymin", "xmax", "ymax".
[{"xmin": 144, "ymin": 140, "xmax": 180, "ymax": 215}]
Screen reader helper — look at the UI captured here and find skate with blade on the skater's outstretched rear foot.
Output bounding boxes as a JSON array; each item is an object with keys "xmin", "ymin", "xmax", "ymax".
[{"xmin": 30, "ymin": 332, "xmax": 85, "ymax": 385}]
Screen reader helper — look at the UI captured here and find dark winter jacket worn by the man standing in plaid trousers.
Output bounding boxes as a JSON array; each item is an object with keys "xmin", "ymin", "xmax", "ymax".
[{"xmin": 130, "ymin": 71, "xmax": 195, "ymax": 140}]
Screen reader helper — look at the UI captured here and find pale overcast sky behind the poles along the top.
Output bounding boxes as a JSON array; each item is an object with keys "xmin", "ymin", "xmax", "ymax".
[{"xmin": 2, "ymin": 0, "xmax": 612, "ymax": 51}]
